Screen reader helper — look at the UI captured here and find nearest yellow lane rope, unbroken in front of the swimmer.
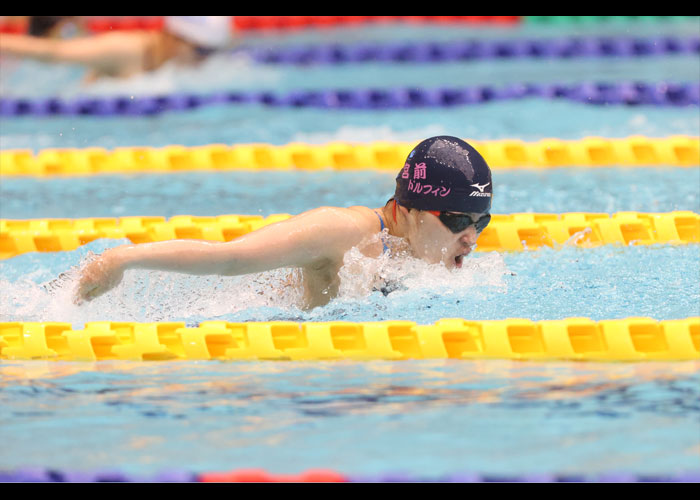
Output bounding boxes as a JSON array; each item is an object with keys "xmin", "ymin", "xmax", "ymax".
[{"xmin": 0, "ymin": 317, "xmax": 700, "ymax": 361}]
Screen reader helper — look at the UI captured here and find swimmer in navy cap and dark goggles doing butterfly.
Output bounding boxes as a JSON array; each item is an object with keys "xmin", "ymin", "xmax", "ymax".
[{"xmin": 76, "ymin": 136, "xmax": 493, "ymax": 308}]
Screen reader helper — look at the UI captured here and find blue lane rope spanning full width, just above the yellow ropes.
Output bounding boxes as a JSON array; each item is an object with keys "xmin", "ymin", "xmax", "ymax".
[{"xmin": 0, "ymin": 82, "xmax": 700, "ymax": 117}]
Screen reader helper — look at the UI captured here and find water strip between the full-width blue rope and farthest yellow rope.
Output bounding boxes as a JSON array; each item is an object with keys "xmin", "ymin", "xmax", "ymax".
[{"xmin": 2, "ymin": 98, "xmax": 700, "ymax": 151}]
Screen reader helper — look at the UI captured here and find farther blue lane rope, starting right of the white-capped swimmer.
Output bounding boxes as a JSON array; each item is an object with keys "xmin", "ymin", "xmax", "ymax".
[{"xmin": 237, "ymin": 36, "xmax": 700, "ymax": 65}]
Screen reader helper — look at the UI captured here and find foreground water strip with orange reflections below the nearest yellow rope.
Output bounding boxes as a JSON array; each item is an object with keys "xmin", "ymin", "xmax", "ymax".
[{"xmin": 0, "ymin": 361, "xmax": 700, "ymax": 479}]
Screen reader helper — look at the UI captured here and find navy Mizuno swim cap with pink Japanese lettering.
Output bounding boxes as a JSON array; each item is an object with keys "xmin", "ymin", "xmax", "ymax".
[{"xmin": 394, "ymin": 135, "xmax": 493, "ymax": 213}]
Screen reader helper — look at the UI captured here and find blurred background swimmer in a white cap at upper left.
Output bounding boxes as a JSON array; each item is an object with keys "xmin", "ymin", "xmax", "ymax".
[{"xmin": 0, "ymin": 16, "xmax": 233, "ymax": 81}]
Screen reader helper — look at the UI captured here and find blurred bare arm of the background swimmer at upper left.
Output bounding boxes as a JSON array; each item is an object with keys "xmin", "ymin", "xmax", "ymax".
[{"xmin": 0, "ymin": 34, "xmax": 143, "ymax": 68}]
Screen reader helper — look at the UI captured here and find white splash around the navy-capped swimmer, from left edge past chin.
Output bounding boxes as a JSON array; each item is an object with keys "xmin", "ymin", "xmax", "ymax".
[{"xmin": 0, "ymin": 234, "xmax": 509, "ymax": 325}]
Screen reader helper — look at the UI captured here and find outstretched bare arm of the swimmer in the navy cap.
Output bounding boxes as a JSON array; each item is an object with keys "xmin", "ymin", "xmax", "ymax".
[{"xmin": 76, "ymin": 207, "xmax": 364, "ymax": 301}]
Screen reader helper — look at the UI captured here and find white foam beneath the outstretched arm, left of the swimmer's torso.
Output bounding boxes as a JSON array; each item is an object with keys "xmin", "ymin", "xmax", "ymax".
[{"xmin": 0, "ymin": 252, "xmax": 300, "ymax": 325}]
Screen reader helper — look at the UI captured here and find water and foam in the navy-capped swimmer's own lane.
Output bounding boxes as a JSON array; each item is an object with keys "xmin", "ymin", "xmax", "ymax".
[{"xmin": 0, "ymin": 240, "xmax": 700, "ymax": 327}]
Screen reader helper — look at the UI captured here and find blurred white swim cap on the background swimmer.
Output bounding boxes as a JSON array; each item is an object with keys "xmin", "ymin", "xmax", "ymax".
[{"xmin": 165, "ymin": 16, "xmax": 232, "ymax": 49}]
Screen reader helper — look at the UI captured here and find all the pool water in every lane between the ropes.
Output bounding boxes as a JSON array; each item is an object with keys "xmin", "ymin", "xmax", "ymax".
[{"xmin": 0, "ymin": 19, "xmax": 700, "ymax": 477}]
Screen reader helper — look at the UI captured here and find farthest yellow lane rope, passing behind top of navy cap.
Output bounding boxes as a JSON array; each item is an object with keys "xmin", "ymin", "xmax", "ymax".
[{"xmin": 0, "ymin": 135, "xmax": 700, "ymax": 176}]
